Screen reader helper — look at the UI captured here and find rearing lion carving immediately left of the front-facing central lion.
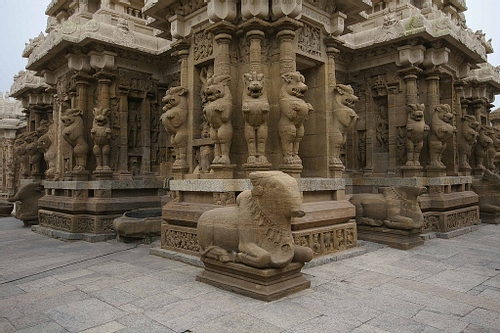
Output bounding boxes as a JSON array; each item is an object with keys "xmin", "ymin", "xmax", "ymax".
[{"xmin": 203, "ymin": 75, "xmax": 233, "ymax": 164}]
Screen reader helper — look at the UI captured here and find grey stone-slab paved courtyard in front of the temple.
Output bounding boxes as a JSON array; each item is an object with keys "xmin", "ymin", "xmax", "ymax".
[{"xmin": 0, "ymin": 218, "xmax": 500, "ymax": 333}]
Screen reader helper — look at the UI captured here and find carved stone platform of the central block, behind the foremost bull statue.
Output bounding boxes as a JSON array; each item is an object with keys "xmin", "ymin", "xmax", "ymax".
[{"xmin": 161, "ymin": 178, "xmax": 357, "ymax": 256}]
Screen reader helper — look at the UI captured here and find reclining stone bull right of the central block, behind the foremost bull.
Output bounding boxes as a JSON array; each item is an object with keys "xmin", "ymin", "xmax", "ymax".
[{"xmin": 350, "ymin": 186, "xmax": 426, "ymax": 230}]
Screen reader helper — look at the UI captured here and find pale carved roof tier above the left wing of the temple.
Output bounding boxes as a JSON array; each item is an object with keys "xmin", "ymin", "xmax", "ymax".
[{"xmin": 23, "ymin": 0, "xmax": 169, "ymax": 71}]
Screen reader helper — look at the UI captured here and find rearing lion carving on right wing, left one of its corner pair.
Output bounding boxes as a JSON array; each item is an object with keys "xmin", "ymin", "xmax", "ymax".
[{"xmin": 406, "ymin": 104, "xmax": 430, "ymax": 166}]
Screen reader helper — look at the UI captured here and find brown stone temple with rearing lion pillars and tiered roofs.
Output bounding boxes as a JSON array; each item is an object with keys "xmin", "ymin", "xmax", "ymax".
[{"xmin": 2, "ymin": 0, "xmax": 500, "ymax": 296}]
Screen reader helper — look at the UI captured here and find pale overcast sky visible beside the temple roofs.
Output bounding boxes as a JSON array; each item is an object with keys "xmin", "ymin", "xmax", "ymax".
[{"xmin": 0, "ymin": 0, "xmax": 500, "ymax": 107}]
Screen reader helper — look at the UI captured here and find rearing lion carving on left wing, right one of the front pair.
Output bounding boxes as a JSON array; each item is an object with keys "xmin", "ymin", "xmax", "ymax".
[{"xmin": 90, "ymin": 108, "xmax": 111, "ymax": 171}]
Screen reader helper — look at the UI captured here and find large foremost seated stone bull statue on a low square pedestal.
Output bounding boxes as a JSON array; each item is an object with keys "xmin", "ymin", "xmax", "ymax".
[{"xmin": 198, "ymin": 171, "xmax": 313, "ymax": 268}]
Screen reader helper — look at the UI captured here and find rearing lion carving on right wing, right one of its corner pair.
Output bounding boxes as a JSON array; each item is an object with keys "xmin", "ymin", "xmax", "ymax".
[{"xmin": 429, "ymin": 104, "xmax": 457, "ymax": 169}]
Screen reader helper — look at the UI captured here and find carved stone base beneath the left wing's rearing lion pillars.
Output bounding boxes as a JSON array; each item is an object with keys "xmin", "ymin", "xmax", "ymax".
[{"xmin": 36, "ymin": 179, "xmax": 162, "ymax": 241}]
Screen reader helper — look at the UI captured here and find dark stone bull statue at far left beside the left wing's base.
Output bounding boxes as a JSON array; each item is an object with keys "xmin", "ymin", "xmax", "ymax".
[{"xmin": 7, "ymin": 182, "xmax": 45, "ymax": 226}]
